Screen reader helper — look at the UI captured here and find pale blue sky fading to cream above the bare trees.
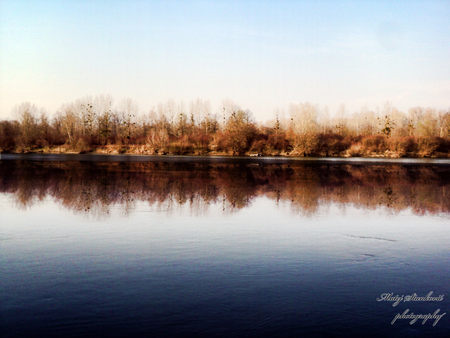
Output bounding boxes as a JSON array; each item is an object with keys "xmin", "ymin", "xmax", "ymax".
[{"xmin": 0, "ymin": 0, "xmax": 450, "ymax": 121}]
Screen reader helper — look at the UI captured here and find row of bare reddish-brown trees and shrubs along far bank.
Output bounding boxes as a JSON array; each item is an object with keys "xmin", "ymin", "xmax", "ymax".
[{"xmin": 0, "ymin": 95, "xmax": 450, "ymax": 157}]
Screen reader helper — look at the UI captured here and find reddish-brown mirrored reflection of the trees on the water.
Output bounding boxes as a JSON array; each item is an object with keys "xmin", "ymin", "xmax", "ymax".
[{"xmin": 0, "ymin": 161, "xmax": 450, "ymax": 217}]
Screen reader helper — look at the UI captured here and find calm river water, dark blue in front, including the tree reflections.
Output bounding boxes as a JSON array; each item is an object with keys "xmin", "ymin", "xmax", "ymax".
[{"xmin": 0, "ymin": 155, "xmax": 450, "ymax": 337}]
